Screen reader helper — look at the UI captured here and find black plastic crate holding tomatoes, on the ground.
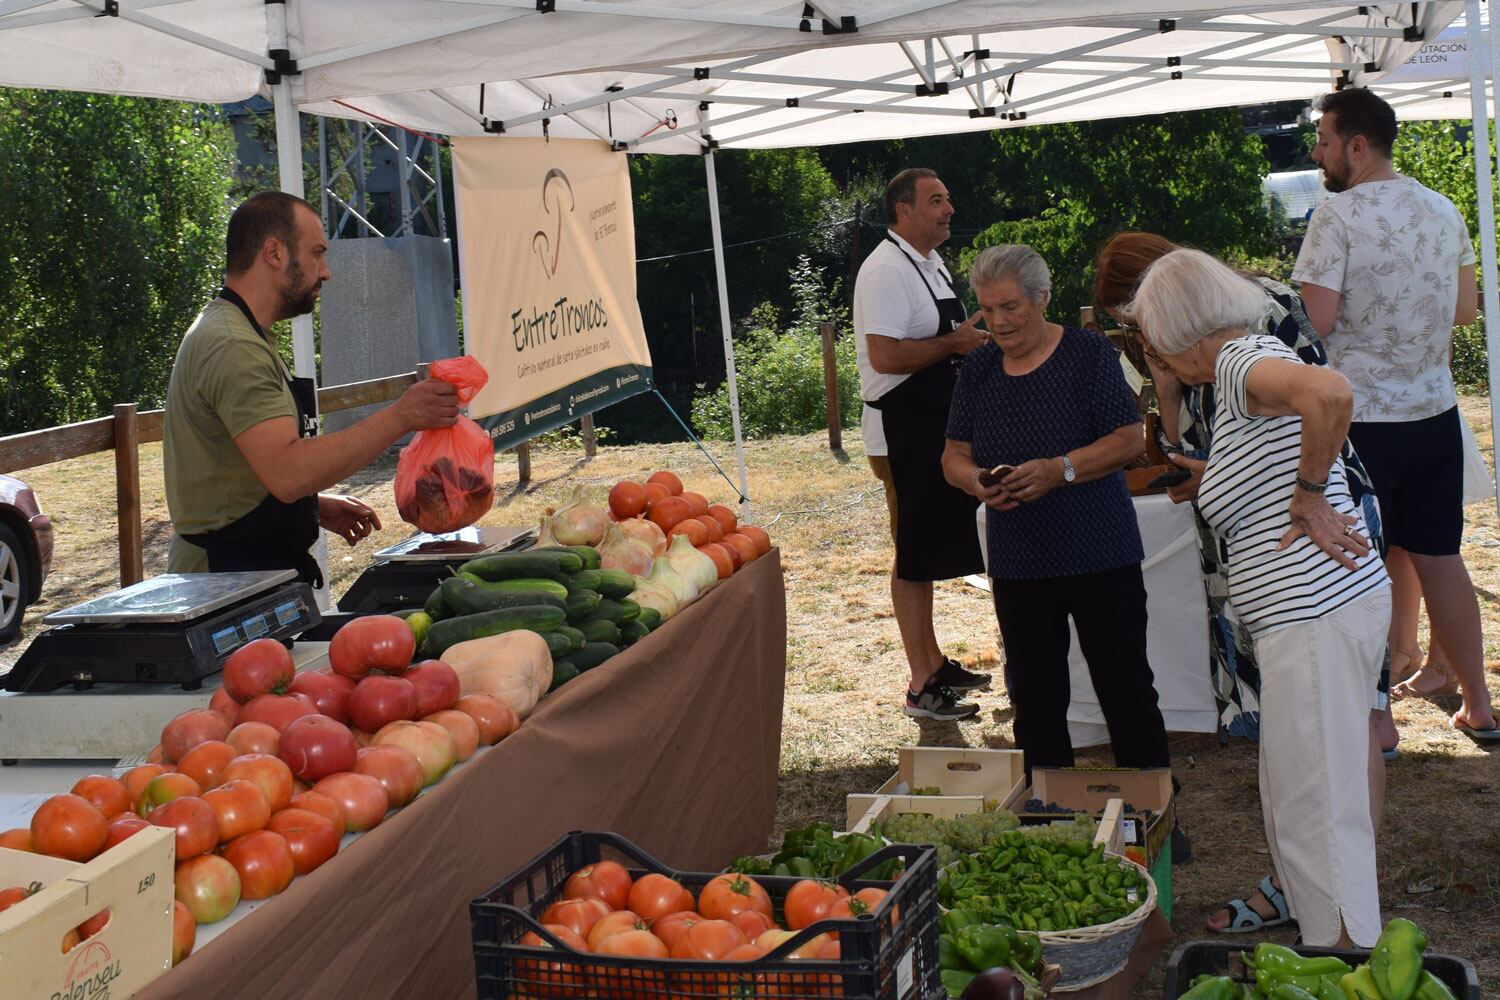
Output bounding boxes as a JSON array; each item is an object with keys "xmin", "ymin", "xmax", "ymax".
[{"xmin": 470, "ymin": 831, "xmax": 942, "ymax": 1000}]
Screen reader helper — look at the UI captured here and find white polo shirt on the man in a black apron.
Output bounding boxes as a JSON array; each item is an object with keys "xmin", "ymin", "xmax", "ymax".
[{"xmin": 854, "ymin": 232, "xmax": 954, "ymax": 456}]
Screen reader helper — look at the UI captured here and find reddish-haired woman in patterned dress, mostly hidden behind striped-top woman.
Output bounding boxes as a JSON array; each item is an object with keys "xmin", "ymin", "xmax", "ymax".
[{"xmin": 1094, "ymin": 231, "xmax": 1398, "ymax": 934}]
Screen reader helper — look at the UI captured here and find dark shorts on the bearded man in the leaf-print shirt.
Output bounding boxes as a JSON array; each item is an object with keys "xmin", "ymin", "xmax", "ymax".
[{"xmin": 1349, "ymin": 406, "xmax": 1464, "ymax": 556}]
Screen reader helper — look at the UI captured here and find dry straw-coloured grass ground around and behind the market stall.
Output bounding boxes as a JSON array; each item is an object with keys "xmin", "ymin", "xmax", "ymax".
[{"xmin": 0, "ymin": 400, "xmax": 1500, "ymax": 997}]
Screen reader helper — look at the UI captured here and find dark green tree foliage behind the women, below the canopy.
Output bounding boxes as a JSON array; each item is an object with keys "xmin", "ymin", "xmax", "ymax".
[{"xmin": 965, "ymin": 109, "xmax": 1278, "ymax": 322}]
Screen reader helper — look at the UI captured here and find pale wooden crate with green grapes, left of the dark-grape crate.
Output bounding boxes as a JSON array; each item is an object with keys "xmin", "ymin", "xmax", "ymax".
[{"xmin": 845, "ymin": 747, "xmax": 1026, "ymax": 832}]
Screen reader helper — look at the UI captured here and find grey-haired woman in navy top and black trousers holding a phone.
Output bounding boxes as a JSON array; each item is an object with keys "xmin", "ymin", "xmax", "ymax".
[{"xmin": 942, "ymin": 246, "xmax": 1170, "ymax": 772}]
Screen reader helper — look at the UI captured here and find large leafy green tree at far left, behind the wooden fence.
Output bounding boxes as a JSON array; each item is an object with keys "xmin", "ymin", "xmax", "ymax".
[{"xmin": 0, "ymin": 90, "xmax": 234, "ymax": 433}]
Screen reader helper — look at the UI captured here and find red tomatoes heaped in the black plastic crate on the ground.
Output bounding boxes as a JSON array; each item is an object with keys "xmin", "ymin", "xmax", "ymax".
[{"xmin": 516, "ymin": 861, "xmax": 887, "ymax": 997}]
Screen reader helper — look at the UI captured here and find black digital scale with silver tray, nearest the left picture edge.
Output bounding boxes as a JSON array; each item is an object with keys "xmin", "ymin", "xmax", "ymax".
[{"xmin": 3, "ymin": 570, "xmax": 321, "ymax": 693}]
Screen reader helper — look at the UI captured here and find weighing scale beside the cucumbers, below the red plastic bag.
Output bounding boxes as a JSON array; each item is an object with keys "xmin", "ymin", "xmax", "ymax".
[{"xmin": 333, "ymin": 526, "xmax": 537, "ymax": 614}]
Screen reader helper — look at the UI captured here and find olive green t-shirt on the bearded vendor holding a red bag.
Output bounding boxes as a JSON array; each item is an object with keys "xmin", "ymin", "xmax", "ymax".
[{"xmin": 162, "ymin": 298, "xmax": 297, "ymax": 573}]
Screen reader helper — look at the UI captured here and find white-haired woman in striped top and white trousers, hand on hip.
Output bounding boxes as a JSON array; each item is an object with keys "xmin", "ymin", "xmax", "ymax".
[{"xmin": 1127, "ymin": 250, "xmax": 1391, "ymax": 948}]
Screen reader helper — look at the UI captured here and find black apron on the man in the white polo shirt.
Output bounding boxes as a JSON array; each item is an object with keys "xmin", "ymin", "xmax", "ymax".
[{"xmin": 867, "ymin": 235, "xmax": 984, "ymax": 582}]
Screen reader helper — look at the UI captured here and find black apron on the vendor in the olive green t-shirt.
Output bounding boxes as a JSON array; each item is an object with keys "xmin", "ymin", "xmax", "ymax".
[{"xmin": 183, "ymin": 288, "xmax": 323, "ymax": 588}]
